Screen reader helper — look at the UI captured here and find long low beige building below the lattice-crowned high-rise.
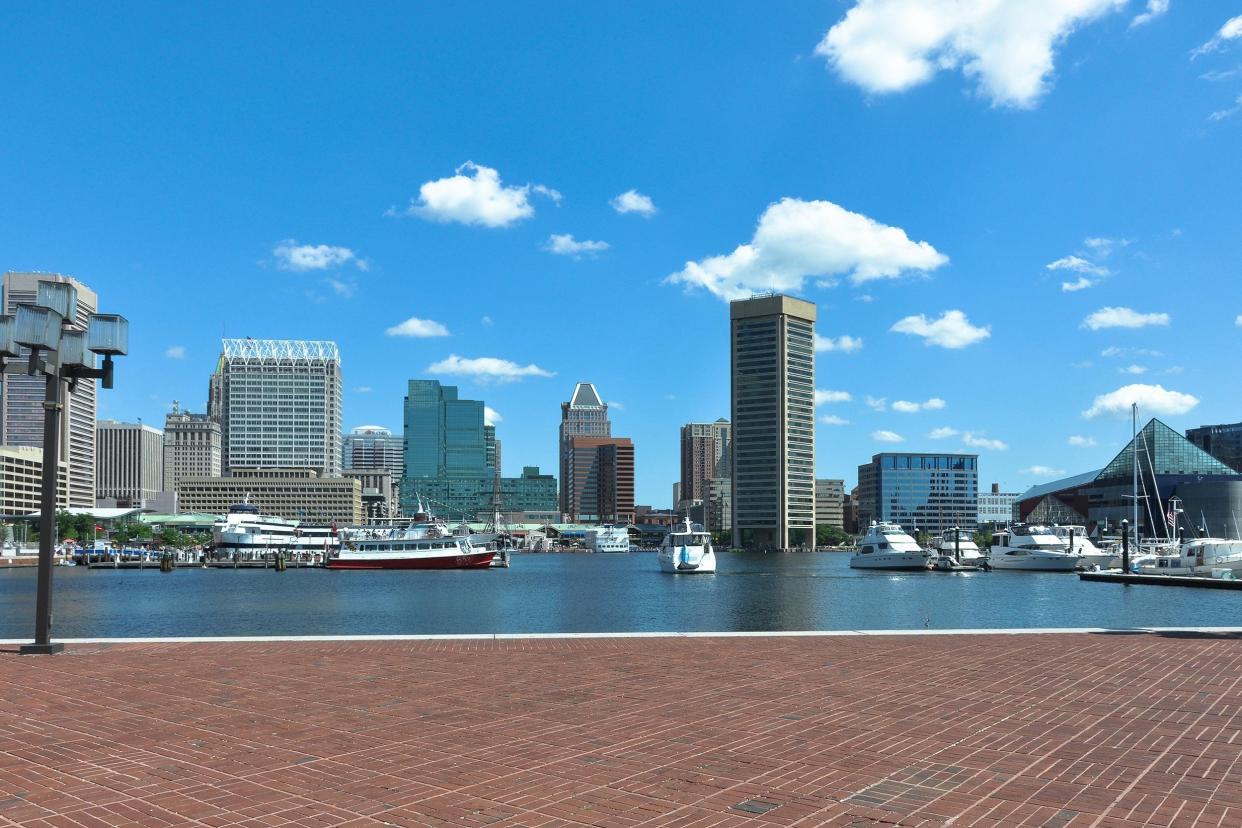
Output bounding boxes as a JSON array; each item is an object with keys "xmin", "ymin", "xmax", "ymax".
[{"xmin": 176, "ymin": 468, "xmax": 363, "ymax": 524}]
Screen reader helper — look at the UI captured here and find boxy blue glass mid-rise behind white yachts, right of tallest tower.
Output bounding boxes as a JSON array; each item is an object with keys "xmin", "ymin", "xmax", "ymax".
[{"xmin": 858, "ymin": 452, "xmax": 979, "ymax": 535}]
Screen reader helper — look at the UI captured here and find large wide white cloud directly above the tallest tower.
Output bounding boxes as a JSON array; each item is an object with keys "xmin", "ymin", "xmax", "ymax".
[{"xmin": 666, "ymin": 199, "xmax": 949, "ymax": 299}]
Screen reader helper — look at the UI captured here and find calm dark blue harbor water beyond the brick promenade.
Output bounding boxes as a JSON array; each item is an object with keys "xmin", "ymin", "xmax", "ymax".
[{"xmin": 0, "ymin": 552, "xmax": 1227, "ymax": 638}]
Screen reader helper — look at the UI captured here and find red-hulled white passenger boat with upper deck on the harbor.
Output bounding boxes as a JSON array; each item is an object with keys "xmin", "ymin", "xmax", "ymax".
[{"xmin": 327, "ymin": 513, "xmax": 496, "ymax": 570}]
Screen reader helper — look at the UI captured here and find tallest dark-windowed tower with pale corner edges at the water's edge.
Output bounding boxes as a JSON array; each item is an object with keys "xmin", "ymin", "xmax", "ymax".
[{"xmin": 729, "ymin": 295, "xmax": 815, "ymax": 549}]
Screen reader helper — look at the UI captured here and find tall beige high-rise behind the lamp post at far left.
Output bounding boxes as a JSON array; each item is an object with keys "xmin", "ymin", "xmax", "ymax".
[{"xmin": 0, "ymin": 273, "xmax": 98, "ymax": 509}]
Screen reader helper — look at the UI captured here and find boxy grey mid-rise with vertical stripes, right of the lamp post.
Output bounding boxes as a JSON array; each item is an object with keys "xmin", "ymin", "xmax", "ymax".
[{"xmin": 96, "ymin": 420, "xmax": 164, "ymax": 508}]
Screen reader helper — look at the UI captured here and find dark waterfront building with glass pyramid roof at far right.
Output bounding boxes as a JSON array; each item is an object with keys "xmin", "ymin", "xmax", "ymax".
[{"xmin": 1015, "ymin": 418, "xmax": 1242, "ymax": 538}]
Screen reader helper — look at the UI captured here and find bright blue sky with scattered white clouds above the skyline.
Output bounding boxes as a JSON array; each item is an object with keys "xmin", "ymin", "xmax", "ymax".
[{"xmin": 0, "ymin": 0, "xmax": 1242, "ymax": 505}]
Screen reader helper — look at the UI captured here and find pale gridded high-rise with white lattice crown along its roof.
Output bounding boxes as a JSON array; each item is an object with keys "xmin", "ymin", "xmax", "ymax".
[{"xmin": 207, "ymin": 339, "xmax": 342, "ymax": 477}]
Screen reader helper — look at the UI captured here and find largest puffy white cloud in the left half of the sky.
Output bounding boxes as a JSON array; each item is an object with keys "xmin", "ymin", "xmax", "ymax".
[{"xmin": 389, "ymin": 161, "xmax": 560, "ymax": 227}]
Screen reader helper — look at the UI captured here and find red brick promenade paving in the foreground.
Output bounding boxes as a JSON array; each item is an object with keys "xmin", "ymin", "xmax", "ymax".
[{"xmin": 0, "ymin": 634, "xmax": 1242, "ymax": 828}]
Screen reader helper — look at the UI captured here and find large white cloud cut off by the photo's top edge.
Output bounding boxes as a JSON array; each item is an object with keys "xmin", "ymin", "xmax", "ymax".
[{"xmin": 815, "ymin": 0, "xmax": 1128, "ymax": 107}]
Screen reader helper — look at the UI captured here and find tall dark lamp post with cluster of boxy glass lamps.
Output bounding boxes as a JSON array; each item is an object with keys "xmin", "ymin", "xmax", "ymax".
[{"xmin": 0, "ymin": 282, "xmax": 129, "ymax": 655}]
